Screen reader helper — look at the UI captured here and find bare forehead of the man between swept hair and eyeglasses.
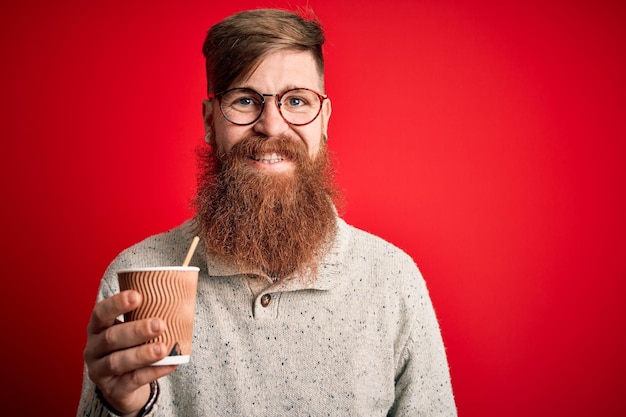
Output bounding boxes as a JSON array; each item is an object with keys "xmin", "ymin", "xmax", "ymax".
[{"xmin": 233, "ymin": 50, "xmax": 323, "ymax": 93}]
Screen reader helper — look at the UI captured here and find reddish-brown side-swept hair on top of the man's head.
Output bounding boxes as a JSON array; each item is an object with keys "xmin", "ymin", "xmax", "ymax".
[{"xmin": 202, "ymin": 8, "xmax": 325, "ymax": 94}]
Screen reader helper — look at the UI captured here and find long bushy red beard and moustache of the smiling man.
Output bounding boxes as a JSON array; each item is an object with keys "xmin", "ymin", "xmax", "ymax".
[{"xmin": 194, "ymin": 136, "xmax": 338, "ymax": 279}]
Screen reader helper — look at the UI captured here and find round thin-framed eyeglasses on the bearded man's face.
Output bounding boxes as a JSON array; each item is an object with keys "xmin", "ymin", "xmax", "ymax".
[{"xmin": 209, "ymin": 88, "xmax": 328, "ymax": 126}]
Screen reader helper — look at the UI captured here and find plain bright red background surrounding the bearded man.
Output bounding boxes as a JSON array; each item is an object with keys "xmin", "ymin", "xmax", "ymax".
[{"xmin": 0, "ymin": 0, "xmax": 626, "ymax": 417}]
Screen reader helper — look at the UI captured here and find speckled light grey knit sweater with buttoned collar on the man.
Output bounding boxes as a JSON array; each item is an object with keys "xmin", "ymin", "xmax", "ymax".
[{"xmin": 78, "ymin": 219, "xmax": 456, "ymax": 417}]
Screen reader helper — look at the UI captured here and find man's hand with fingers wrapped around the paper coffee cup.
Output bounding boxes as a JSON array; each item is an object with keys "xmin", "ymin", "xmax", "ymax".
[{"xmin": 83, "ymin": 290, "xmax": 176, "ymax": 413}]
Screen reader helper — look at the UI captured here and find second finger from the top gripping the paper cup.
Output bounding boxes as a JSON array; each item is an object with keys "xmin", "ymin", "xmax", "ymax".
[{"xmin": 84, "ymin": 318, "xmax": 165, "ymax": 362}]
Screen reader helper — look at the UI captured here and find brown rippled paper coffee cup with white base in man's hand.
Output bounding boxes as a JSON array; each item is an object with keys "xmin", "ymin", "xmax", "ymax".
[{"xmin": 117, "ymin": 266, "xmax": 200, "ymax": 365}]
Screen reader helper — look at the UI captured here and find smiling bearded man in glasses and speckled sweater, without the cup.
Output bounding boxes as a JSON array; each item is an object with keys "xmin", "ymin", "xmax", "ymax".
[{"xmin": 78, "ymin": 10, "xmax": 456, "ymax": 416}]
